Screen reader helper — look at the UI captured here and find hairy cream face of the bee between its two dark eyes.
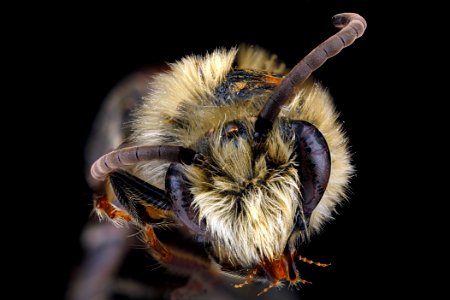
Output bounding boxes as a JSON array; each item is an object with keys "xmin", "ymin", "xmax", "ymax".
[{"xmin": 186, "ymin": 120, "xmax": 300, "ymax": 267}]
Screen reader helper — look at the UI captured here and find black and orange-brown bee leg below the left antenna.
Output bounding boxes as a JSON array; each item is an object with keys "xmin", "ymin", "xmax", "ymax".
[{"xmin": 95, "ymin": 171, "xmax": 234, "ymax": 299}]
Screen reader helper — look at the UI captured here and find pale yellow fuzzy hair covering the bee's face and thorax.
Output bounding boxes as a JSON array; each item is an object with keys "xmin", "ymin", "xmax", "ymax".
[{"xmin": 130, "ymin": 48, "xmax": 353, "ymax": 266}]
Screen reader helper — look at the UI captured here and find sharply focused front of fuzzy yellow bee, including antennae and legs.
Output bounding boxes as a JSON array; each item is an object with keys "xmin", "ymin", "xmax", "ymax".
[{"xmin": 91, "ymin": 13, "xmax": 367, "ymax": 294}]
